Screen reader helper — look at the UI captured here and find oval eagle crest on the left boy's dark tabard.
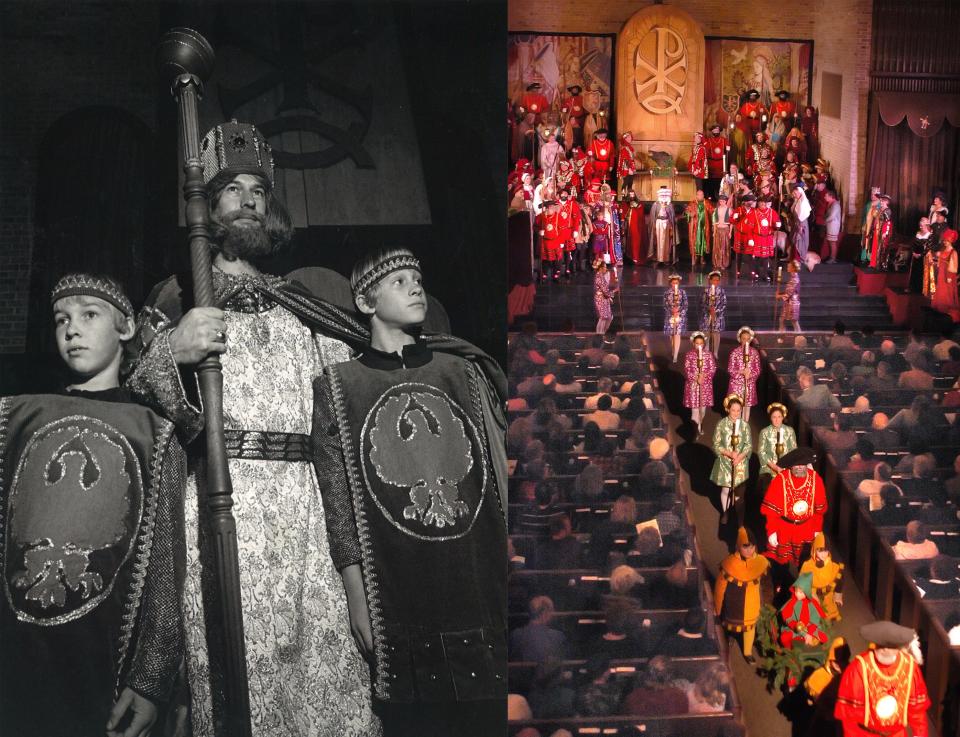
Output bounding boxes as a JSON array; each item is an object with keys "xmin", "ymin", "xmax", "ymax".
[{"xmin": 3, "ymin": 416, "xmax": 143, "ymax": 625}]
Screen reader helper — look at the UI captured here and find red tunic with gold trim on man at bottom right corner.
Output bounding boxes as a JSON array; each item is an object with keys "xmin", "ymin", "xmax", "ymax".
[{"xmin": 833, "ymin": 650, "xmax": 930, "ymax": 737}]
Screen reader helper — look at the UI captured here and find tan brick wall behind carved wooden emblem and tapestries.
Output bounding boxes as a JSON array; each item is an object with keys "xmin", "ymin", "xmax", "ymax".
[{"xmin": 508, "ymin": 0, "xmax": 872, "ymax": 230}]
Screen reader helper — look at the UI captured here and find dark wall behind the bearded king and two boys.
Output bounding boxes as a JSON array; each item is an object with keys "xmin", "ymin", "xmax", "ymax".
[{"xmin": 0, "ymin": 0, "xmax": 506, "ymax": 392}]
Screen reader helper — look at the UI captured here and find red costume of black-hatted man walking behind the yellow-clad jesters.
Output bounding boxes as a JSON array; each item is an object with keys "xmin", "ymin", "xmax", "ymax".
[{"xmin": 760, "ymin": 468, "xmax": 827, "ymax": 566}]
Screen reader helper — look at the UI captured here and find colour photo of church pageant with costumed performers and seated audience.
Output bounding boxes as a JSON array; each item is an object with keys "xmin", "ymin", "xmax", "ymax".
[{"xmin": 504, "ymin": 0, "xmax": 960, "ymax": 737}]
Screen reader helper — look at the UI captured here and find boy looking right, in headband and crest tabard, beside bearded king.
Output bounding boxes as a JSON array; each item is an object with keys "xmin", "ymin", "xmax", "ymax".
[{"xmin": 312, "ymin": 248, "xmax": 507, "ymax": 737}]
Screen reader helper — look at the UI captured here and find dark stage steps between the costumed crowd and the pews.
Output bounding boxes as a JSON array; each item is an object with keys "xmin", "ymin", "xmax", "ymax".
[{"xmin": 518, "ymin": 264, "xmax": 894, "ymax": 331}]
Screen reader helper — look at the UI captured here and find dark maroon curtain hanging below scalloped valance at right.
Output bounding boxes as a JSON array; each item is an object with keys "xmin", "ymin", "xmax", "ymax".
[{"xmin": 865, "ymin": 101, "xmax": 960, "ymax": 237}]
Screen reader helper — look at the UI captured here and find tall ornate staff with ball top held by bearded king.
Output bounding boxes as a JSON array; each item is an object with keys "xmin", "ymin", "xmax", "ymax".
[{"xmin": 157, "ymin": 28, "xmax": 251, "ymax": 737}]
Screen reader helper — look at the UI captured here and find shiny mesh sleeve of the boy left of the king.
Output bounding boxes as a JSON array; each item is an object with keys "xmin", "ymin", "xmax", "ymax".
[{"xmin": 124, "ymin": 437, "xmax": 186, "ymax": 702}]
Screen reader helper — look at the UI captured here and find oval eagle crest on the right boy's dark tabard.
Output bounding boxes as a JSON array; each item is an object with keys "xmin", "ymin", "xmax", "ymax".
[{"xmin": 361, "ymin": 383, "xmax": 487, "ymax": 540}]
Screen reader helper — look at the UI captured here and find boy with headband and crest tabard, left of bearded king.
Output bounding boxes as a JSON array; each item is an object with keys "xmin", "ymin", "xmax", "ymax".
[{"xmin": 0, "ymin": 274, "xmax": 185, "ymax": 737}]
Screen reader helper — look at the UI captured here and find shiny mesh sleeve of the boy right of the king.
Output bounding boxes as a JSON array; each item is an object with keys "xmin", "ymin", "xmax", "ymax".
[{"xmin": 310, "ymin": 376, "xmax": 360, "ymax": 571}]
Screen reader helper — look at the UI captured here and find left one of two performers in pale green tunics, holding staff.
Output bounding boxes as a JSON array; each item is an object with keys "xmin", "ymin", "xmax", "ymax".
[{"xmin": 710, "ymin": 394, "xmax": 753, "ymax": 525}]
